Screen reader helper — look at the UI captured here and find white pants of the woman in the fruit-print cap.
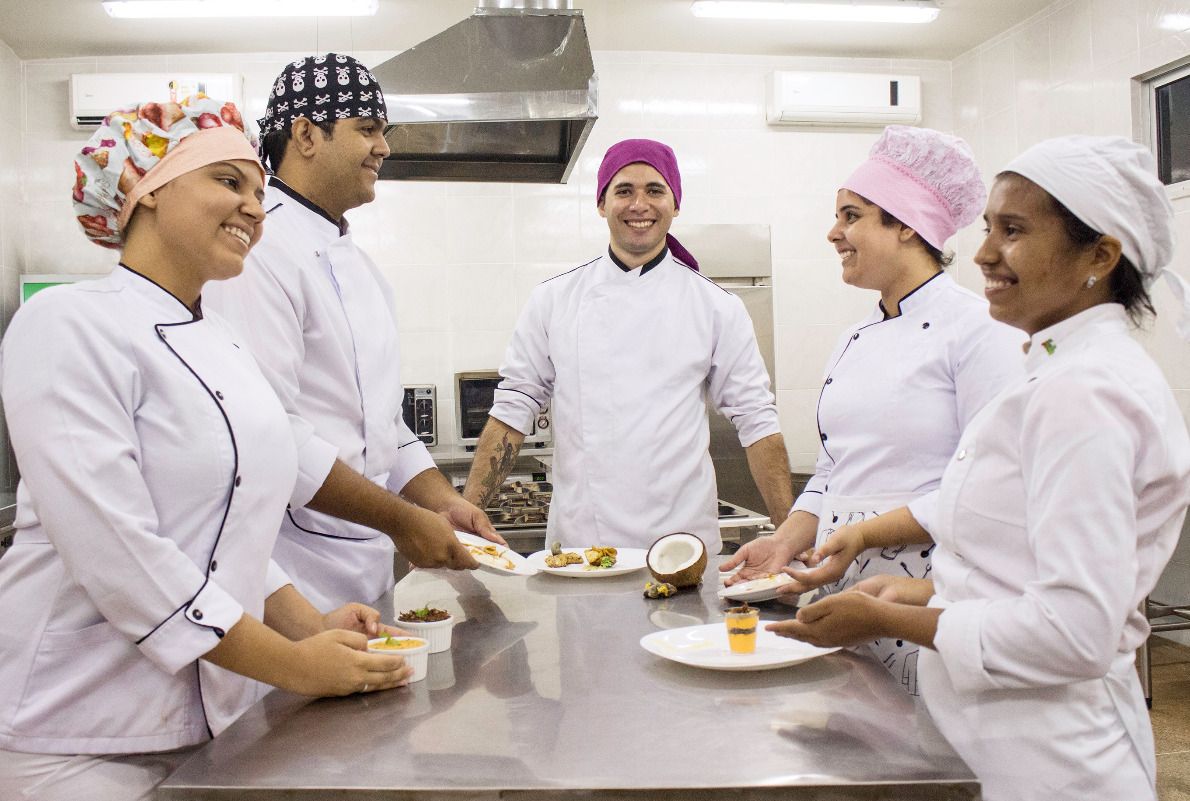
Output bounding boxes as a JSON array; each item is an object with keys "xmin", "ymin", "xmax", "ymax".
[{"xmin": 0, "ymin": 745, "xmax": 199, "ymax": 801}]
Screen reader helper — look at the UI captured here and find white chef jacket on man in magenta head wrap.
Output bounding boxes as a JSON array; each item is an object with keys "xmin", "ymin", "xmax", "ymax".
[{"xmin": 491, "ymin": 254, "xmax": 779, "ymax": 553}]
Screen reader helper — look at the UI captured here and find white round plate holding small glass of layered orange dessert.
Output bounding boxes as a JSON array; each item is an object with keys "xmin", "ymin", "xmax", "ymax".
[{"xmin": 640, "ymin": 620, "xmax": 839, "ymax": 670}]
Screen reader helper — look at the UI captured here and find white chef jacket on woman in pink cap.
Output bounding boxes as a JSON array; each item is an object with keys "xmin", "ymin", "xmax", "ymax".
[{"xmin": 794, "ymin": 273, "xmax": 1025, "ymax": 530}]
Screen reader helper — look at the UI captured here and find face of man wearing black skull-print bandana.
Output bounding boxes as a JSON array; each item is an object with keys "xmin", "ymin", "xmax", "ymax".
[{"xmin": 309, "ymin": 117, "xmax": 389, "ymax": 219}]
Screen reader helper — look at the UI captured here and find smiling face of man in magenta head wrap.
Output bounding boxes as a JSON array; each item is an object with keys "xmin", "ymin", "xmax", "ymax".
[{"xmin": 599, "ymin": 163, "xmax": 678, "ymax": 267}]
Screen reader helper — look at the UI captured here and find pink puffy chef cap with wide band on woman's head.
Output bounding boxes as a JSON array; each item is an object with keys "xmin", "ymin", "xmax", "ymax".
[{"xmin": 843, "ymin": 125, "xmax": 988, "ymax": 250}]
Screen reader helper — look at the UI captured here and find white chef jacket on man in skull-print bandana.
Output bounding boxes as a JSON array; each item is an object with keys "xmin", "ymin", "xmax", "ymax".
[{"xmin": 203, "ymin": 177, "xmax": 434, "ymax": 612}]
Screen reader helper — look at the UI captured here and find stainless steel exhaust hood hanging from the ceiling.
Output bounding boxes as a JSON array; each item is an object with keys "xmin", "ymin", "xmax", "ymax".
[{"xmin": 372, "ymin": 0, "xmax": 597, "ymax": 183}]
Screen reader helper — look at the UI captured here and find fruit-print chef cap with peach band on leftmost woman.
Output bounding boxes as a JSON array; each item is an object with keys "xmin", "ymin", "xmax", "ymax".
[{"xmin": 71, "ymin": 94, "xmax": 264, "ymax": 250}]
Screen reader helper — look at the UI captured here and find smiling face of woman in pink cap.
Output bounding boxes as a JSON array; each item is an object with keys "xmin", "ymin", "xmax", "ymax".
[{"xmin": 826, "ymin": 189, "xmax": 913, "ymax": 293}]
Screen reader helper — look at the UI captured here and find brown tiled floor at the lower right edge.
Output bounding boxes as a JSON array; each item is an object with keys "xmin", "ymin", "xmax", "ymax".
[{"xmin": 1150, "ymin": 637, "xmax": 1190, "ymax": 801}]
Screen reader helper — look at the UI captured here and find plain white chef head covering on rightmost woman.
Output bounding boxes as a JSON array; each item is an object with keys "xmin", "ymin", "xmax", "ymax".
[{"xmin": 1004, "ymin": 134, "xmax": 1190, "ymax": 340}]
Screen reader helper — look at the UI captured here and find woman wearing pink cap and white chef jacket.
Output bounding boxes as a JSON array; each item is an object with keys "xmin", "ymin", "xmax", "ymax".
[{"xmin": 721, "ymin": 126, "xmax": 1021, "ymax": 695}]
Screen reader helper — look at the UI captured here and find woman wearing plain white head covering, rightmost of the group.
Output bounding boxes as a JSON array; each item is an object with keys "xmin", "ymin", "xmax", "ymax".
[{"xmin": 770, "ymin": 136, "xmax": 1190, "ymax": 801}]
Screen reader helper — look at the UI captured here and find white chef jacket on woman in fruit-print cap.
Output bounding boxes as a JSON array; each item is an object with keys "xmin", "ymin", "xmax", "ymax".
[{"xmin": 0, "ymin": 267, "xmax": 333, "ymax": 753}]
